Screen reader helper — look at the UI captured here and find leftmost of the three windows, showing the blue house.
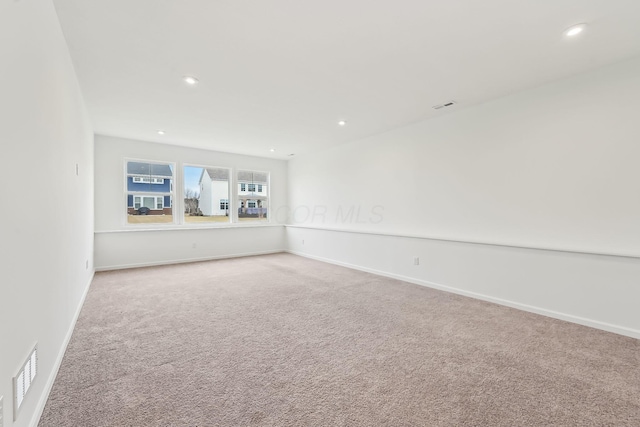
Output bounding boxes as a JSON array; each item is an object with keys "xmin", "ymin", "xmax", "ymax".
[{"xmin": 125, "ymin": 160, "xmax": 174, "ymax": 224}]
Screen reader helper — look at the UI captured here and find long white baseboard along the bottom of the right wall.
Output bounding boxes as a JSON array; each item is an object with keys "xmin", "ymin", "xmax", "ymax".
[{"xmin": 286, "ymin": 250, "xmax": 640, "ymax": 339}]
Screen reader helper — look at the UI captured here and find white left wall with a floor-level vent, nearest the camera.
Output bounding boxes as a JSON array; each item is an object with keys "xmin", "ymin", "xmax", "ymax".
[{"xmin": 0, "ymin": 0, "xmax": 93, "ymax": 427}]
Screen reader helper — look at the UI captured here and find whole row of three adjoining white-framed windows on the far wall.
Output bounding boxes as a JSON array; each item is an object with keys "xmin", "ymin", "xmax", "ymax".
[{"xmin": 124, "ymin": 159, "xmax": 271, "ymax": 226}]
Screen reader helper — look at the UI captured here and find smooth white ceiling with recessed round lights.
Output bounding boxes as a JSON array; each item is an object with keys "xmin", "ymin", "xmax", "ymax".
[{"xmin": 54, "ymin": 0, "xmax": 640, "ymax": 158}]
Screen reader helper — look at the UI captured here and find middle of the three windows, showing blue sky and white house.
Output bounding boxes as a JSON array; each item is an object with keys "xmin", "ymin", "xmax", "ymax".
[{"xmin": 184, "ymin": 166, "xmax": 231, "ymax": 223}]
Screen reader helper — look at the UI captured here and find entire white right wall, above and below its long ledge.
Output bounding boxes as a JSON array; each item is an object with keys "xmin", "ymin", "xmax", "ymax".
[{"xmin": 287, "ymin": 58, "xmax": 640, "ymax": 336}]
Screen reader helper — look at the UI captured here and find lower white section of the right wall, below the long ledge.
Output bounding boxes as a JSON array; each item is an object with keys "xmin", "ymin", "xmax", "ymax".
[{"xmin": 287, "ymin": 226, "xmax": 640, "ymax": 338}]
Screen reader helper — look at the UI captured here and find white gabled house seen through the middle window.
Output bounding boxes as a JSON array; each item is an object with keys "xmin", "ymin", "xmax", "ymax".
[{"xmin": 198, "ymin": 168, "xmax": 229, "ymax": 216}]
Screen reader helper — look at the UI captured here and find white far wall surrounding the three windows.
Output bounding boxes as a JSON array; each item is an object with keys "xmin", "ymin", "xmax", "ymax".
[{"xmin": 95, "ymin": 135, "xmax": 287, "ymax": 270}]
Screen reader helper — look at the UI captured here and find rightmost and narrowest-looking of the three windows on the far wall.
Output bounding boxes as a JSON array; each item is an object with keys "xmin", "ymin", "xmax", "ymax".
[{"xmin": 237, "ymin": 171, "xmax": 269, "ymax": 222}]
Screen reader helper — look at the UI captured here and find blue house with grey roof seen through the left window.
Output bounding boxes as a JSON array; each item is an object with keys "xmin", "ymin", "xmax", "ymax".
[{"xmin": 127, "ymin": 162, "xmax": 173, "ymax": 215}]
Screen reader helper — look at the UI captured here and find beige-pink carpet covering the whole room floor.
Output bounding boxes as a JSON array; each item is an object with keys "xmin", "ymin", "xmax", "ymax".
[{"xmin": 39, "ymin": 254, "xmax": 640, "ymax": 427}]
